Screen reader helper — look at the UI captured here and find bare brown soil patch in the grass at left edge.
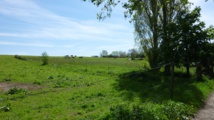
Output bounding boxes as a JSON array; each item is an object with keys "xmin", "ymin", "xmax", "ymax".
[{"xmin": 0, "ymin": 82, "xmax": 41, "ymax": 92}]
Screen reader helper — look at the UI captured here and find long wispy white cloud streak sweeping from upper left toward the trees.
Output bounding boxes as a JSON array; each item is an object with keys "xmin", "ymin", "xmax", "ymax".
[{"xmin": 0, "ymin": 0, "xmax": 132, "ymax": 41}]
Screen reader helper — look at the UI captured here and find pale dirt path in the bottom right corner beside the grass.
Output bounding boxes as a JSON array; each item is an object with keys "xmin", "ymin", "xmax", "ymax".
[{"xmin": 192, "ymin": 92, "xmax": 214, "ymax": 120}]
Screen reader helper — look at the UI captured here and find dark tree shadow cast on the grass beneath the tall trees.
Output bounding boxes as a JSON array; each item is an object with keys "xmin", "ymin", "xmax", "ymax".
[{"xmin": 114, "ymin": 71, "xmax": 204, "ymax": 107}]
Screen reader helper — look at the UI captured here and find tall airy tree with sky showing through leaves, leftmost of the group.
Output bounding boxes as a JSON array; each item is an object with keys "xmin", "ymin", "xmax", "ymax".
[{"xmin": 132, "ymin": 0, "xmax": 160, "ymax": 67}]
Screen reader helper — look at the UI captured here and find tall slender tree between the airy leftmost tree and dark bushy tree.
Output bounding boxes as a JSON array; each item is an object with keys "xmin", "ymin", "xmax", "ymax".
[{"xmin": 156, "ymin": 0, "xmax": 189, "ymax": 74}]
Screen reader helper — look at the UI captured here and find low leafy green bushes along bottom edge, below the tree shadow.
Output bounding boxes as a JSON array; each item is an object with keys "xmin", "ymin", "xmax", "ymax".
[{"xmin": 103, "ymin": 101, "xmax": 194, "ymax": 120}]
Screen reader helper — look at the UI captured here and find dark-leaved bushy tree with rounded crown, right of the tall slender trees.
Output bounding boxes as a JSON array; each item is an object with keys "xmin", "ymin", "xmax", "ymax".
[{"xmin": 170, "ymin": 7, "xmax": 208, "ymax": 76}]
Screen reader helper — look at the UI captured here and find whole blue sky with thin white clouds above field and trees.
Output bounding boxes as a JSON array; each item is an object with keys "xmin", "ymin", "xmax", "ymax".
[{"xmin": 0, "ymin": 0, "xmax": 214, "ymax": 56}]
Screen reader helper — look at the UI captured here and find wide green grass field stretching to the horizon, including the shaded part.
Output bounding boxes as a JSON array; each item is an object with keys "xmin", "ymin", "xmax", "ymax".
[{"xmin": 0, "ymin": 56, "xmax": 214, "ymax": 120}]
